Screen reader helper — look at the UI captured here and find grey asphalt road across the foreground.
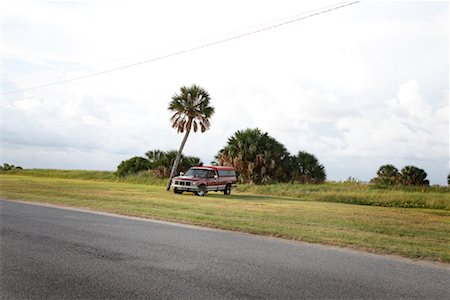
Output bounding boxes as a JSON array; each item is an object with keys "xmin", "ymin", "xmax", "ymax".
[{"xmin": 0, "ymin": 201, "xmax": 450, "ymax": 299}]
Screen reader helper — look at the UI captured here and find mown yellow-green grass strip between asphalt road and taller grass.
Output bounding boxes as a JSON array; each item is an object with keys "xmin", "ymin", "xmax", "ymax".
[{"xmin": 0, "ymin": 174, "xmax": 450, "ymax": 263}]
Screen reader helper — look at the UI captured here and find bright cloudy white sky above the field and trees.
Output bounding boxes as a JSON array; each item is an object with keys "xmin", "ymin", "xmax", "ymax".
[{"xmin": 0, "ymin": 0, "xmax": 449, "ymax": 185}]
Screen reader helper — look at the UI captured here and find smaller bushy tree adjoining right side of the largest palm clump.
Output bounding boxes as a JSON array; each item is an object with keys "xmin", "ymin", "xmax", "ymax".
[{"xmin": 291, "ymin": 151, "xmax": 327, "ymax": 183}]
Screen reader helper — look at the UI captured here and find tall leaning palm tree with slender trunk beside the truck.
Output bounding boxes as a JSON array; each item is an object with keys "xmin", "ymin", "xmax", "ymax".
[{"xmin": 166, "ymin": 84, "xmax": 214, "ymax": 190}]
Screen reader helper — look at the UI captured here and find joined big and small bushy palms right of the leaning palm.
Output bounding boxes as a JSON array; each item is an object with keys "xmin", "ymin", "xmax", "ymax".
[{"xmin": 216, "ymin": 128, "xmax": 326, "ymax": 184}]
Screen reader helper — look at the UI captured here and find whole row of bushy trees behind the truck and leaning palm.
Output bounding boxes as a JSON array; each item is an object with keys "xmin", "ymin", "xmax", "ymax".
[{"xmin": 116, "ymin": 128, "xmax": 326, "ymax": 183}]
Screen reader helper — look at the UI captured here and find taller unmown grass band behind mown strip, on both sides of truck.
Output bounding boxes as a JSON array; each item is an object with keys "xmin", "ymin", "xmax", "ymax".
[{"xmin": 0, "ymin": 169, "xmax": 450, "ymax": 210}]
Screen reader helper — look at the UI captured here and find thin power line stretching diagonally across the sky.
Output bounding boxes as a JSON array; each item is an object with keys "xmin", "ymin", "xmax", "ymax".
[{"xmin": 2, "ymin": 0, "xmax": 361, "ymax": 95}]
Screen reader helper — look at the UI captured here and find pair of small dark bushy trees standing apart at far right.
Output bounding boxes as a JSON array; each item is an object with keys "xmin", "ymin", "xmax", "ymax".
[{"xmin": 371, "ymin": 165, "xmax": 430, "ymax": 186}]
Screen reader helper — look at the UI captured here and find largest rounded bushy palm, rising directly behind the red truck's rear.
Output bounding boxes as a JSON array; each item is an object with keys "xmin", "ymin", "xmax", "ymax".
[{"xmin": 216, "ymin": 128, "xmax": 289, "ymax": 183}]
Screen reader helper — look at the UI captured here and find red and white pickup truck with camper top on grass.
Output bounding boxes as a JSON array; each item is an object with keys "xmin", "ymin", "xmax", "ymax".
[{"xmin": 172, "ymin": 166, "xmax": 236, "ymax": 196}]
